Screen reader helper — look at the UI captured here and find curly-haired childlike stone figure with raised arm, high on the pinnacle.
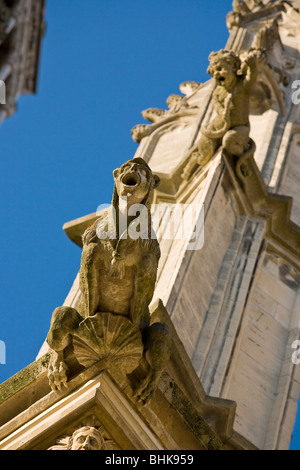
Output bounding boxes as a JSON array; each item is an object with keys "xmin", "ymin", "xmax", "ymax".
[{"xmin": 182, "ymin": 50, "xmax": 264, "ymax": 181}]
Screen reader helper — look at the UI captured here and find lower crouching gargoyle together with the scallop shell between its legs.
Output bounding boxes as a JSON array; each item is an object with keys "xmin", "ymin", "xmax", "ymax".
[{"xmin": 47, "ymin": 158, "xmax": 171, "ymax": 404}]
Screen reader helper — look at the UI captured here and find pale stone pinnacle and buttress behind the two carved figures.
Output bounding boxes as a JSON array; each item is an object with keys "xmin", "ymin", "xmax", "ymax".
[{"xmin": 32, "ymin": 0, "xmax": 300, "ymax": 449}]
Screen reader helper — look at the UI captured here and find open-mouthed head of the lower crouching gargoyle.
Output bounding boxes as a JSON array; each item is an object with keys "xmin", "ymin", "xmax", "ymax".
[{"xmin": 113, "ymin": 158, "xmax": 159, "ymax": 205}]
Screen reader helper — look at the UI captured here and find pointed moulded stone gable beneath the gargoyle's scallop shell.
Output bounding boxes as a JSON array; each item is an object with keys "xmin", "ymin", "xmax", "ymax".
[{"xmin": 0, "ymin": 314, "xmax": 235, "ymax": 450}]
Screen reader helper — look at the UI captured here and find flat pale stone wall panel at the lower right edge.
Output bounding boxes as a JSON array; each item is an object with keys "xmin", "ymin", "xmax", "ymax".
[{"xmin": 221, "ymin": 253, "xmax": 300, "ymax": 449}]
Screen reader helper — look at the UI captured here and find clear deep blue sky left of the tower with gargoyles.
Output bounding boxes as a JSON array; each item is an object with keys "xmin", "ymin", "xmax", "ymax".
[{"xmin": 0, "ymin": 0, "xmax": 300, "ymax": 448}]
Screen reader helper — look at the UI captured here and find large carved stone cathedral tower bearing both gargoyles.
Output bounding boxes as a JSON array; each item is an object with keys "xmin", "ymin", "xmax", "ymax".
[{"xmin": 0, "ymin": 0, "xmax": 300, "ymax": 450}]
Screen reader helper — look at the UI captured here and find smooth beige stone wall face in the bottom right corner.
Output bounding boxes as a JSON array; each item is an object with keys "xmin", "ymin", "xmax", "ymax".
[{"xmin": 220, "ymin": 253, "xmax": 299, "ymax": 448}]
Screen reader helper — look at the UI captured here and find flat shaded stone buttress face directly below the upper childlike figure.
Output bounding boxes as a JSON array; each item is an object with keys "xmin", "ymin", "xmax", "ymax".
[{"xmin": 165, "ymin": 167, "xmax": 236, "ymax": 358}]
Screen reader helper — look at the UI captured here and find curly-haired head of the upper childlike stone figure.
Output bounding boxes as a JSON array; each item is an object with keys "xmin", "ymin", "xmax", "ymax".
[{"xmin": 207, "ymin": 49, "xmax": 241, "ymax": 89}]
